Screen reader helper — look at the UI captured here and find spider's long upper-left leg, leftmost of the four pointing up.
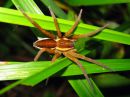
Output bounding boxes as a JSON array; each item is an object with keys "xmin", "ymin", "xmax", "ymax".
[{"xmin": 19, "ymin": 8, "xmax": 55, "ymax": 39}]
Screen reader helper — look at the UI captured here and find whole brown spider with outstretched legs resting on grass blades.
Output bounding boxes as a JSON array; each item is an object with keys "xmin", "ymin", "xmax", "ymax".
[{"xmin": 20, "ymin": 8, "xmax": 111, "ymax": 86}]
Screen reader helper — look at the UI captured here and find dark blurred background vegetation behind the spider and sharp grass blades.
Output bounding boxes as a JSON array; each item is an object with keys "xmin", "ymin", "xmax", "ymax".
[{"xmin": 0, "ymin": 0, "xmax": 130, "ymax": 97}]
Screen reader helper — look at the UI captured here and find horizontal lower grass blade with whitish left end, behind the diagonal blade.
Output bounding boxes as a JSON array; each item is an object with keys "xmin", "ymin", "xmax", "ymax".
[{"xmin": 0, "ymin": 59, "xmax": 130, "ymax": 81}]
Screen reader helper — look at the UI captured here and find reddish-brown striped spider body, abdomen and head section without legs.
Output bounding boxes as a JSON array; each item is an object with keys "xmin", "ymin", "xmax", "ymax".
[{"xmin": 33, "ymin": 38, "xmax": 75, "ymax": 52}]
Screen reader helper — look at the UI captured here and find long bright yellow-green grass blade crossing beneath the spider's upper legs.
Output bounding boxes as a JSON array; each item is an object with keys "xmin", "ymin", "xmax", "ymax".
[{"xmin": 0, "ymin": 8, "xmax": 130, "ymax": 44}]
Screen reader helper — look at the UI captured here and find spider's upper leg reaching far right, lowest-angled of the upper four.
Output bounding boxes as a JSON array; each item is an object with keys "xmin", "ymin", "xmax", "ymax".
[{"xmin": 72, "ymin": 24, "xmax": 109, "ymax": 39}]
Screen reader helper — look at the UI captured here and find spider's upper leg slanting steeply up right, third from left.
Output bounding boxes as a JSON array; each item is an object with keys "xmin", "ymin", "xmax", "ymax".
[{"xmin": 65, "ymin": 9, "xmax": 82, "ymax": 37}]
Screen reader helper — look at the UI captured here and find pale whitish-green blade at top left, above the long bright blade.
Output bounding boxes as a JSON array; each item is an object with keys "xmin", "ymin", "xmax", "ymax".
[{"xmin": 12, "ymin": 0, "xmax": 43, "ymax": 14}]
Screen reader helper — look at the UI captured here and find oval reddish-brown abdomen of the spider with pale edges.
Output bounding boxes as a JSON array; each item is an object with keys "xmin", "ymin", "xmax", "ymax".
[{"xmin": 33, "ymin": 39, "xmax": 56, "ymax": 48}]
